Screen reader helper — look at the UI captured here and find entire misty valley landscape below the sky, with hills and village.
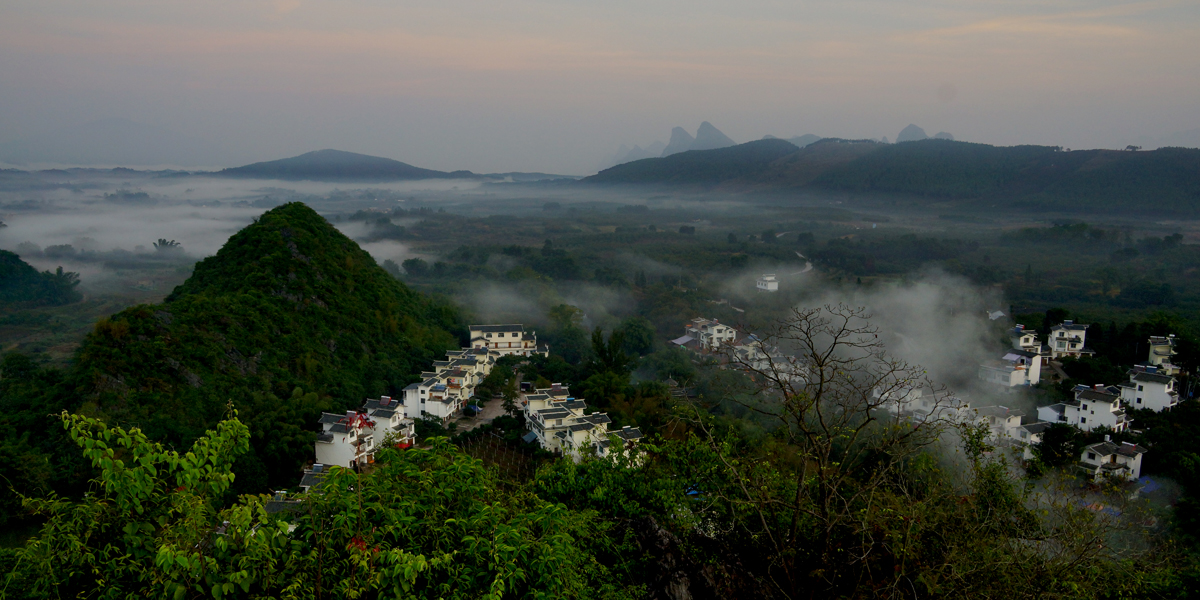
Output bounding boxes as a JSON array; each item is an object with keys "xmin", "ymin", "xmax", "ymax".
[{"xmin": 0, "ymin": 142, "xmax": 1200, "ymax": 599}]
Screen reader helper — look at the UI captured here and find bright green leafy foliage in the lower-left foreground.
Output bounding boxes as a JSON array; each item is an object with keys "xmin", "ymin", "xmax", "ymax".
[{"xmin": 4, "ymin": 414, "xmax": 623, "ymax": 600}]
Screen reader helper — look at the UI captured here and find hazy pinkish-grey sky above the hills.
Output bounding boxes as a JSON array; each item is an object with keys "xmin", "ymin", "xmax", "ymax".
[{"xmin": 0, "ymin": 0, "xmax": 1200, "ymax": 174}]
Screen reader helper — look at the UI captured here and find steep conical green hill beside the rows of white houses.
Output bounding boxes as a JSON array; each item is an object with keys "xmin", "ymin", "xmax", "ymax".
[{"xmin": 73, "ymin": 203, "xmax": 458, "ymax": 491}]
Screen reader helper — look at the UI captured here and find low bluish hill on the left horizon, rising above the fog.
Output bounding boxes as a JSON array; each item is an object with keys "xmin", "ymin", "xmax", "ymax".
[{"xmin": 217, "ymin": 150, "xmax": 478, "ymax": 181}]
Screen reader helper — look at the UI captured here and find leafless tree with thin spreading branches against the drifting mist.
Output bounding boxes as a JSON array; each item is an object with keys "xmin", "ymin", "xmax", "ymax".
[{"xmin": 696, "ymin": 305, "xmax": 952, "ymax": 595}]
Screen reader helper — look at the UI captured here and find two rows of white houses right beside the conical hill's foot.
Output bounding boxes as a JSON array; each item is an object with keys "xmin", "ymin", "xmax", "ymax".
[{"xmin": 301, "ymin": 324, "xmax": 642, "ymax": 490}]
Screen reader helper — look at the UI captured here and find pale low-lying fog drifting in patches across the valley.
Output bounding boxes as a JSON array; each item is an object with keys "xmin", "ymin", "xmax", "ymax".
[{"xmin": 0, "ymin": 173, "xmax": 1022, "ymax": 408}]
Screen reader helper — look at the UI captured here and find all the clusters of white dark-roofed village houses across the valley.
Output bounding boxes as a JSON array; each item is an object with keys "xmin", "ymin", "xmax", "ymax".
[{"xmin": 301, "ymin": 309, "xmax": 1180, "ymax": 488}]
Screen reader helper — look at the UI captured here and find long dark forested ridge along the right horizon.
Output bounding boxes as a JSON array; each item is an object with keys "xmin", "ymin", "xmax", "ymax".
[{"xmin": 584, "ymin": 139, "xmax": 1200, "ymax": 214}]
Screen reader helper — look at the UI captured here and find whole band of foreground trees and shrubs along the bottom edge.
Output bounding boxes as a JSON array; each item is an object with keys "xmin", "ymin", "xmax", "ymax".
[{"xmin": 0, "ymin": 308, "xmax": 1200, "ymax": 600}]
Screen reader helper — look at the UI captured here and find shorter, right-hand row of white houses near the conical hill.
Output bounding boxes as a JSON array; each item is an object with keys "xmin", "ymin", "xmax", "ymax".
[{"xmin": 522, "ymin": 384, "xmax": 642, "ymax": 461}]
